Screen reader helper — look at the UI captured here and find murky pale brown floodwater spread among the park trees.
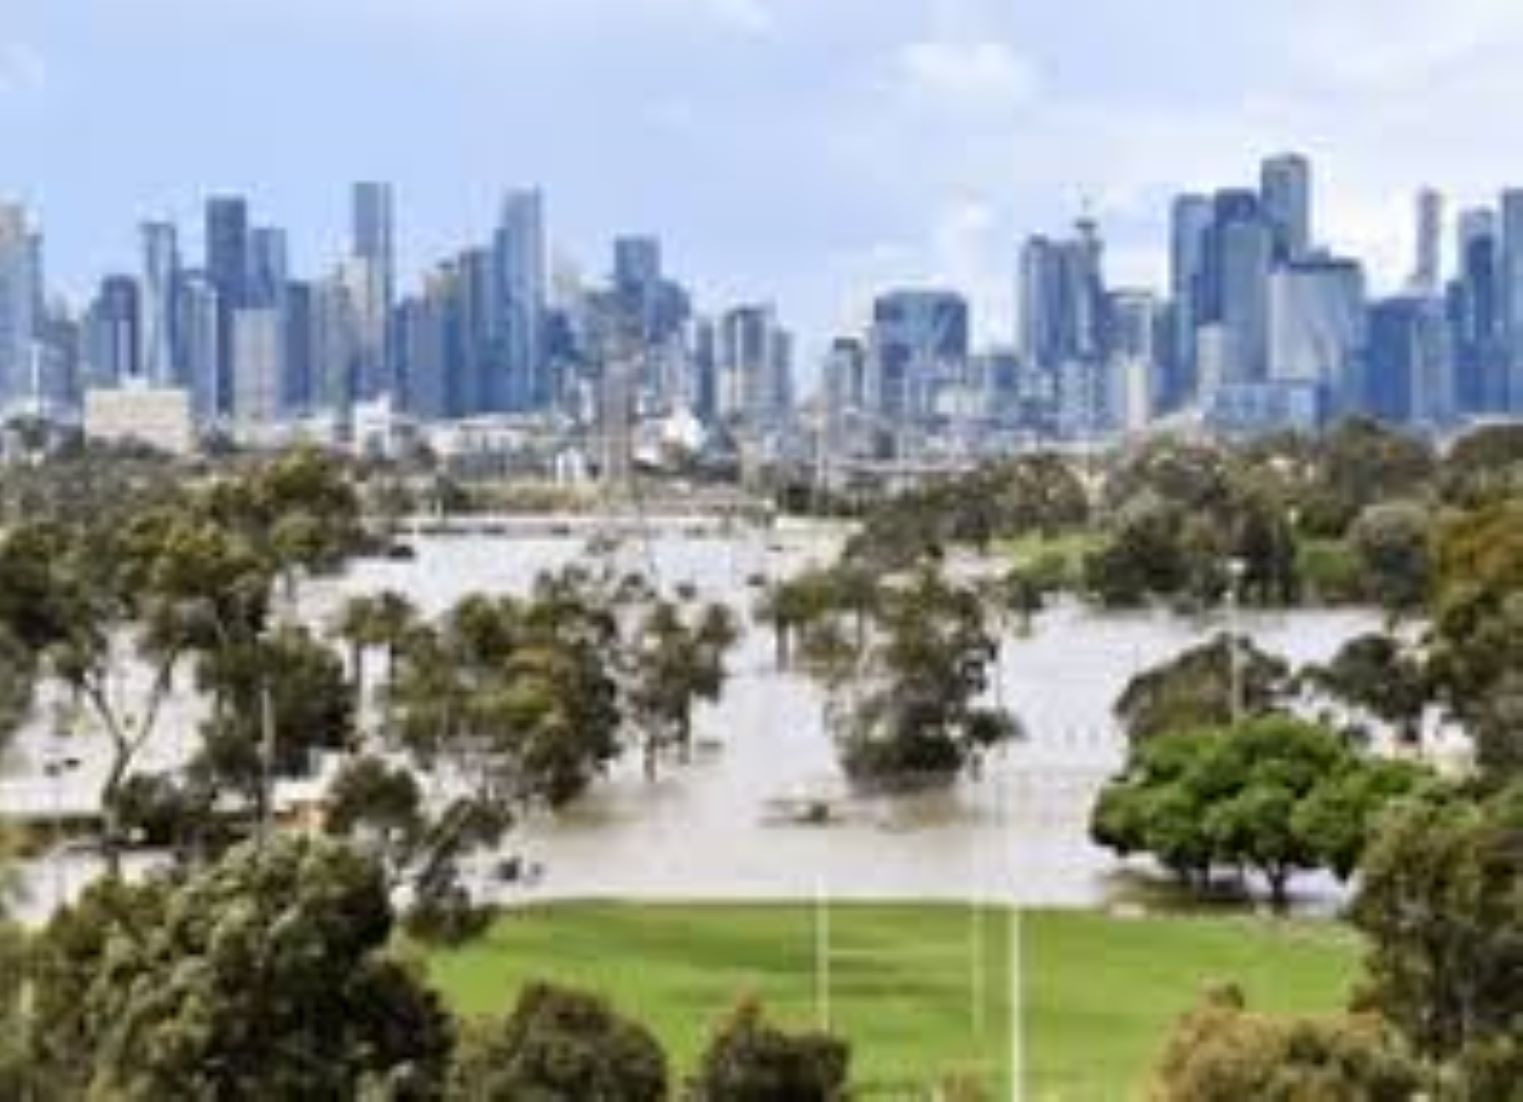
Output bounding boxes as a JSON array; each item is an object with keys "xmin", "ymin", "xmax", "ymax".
[{"xmin": 0, "ymin": 524, "xmax": 1378, "ymax": 913}]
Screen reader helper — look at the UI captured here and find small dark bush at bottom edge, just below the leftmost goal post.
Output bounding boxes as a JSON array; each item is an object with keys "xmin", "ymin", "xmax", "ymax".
[{"xmin": 693, "ymin": 1002, "xmax": 851, "ymax": 1102}]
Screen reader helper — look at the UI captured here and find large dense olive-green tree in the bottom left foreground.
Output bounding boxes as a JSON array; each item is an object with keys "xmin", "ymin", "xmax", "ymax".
[{"xmin": 26, "ymin": 839, "xmax": 452, "ymax": 1102}]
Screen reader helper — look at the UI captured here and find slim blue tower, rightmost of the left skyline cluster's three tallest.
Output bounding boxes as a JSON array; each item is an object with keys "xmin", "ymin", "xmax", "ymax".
[{"xmin": 486, "ymin": 189, "xmax": 550, "ymax": 409}]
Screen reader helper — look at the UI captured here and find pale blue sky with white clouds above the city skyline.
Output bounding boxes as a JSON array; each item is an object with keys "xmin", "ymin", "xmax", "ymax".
[{"xmin": 0, "ymin": 0, "xmax": 1523, "ymax": 362}]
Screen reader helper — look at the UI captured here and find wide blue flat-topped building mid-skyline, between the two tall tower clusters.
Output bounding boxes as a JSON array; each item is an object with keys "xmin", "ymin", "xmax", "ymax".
[{"xmin": 868, "ymin": 289, "xmax": 970, "ymax": 422}]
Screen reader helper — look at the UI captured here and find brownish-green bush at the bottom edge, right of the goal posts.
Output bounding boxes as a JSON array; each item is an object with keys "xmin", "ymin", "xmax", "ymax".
[{"xmin": 1153, "ymin": 997, "xmax": 1424, "ymax": 1102}]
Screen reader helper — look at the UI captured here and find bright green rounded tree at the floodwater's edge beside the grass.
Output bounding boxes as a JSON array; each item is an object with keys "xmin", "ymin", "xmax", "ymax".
[{"xmin": 1090, "ymin": 717, "xmax": 1424, "ymax": 904}]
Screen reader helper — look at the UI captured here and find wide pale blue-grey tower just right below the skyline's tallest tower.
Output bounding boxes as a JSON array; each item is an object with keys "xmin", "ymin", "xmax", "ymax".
[{"xmin": 1269, "ymin": 259, "xmax": 1368, "ymax": 412}]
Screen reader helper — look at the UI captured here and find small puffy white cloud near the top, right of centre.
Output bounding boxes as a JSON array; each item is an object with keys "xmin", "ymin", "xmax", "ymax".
[{"xmin": 899, "ymin": 40, "xmax": 1039, "ymax": 114}]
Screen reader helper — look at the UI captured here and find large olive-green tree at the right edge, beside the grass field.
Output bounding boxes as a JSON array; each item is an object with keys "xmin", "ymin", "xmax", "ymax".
[{"xmin": 1351, "ymin": 787, "xmax": 1523, "ymax": 1077}]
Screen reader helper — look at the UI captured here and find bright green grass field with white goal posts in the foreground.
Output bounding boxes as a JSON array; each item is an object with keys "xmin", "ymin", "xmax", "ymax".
[{"xmin": 431, "ymin": 904, "xmax": 1357, "ymax": 1102}]
